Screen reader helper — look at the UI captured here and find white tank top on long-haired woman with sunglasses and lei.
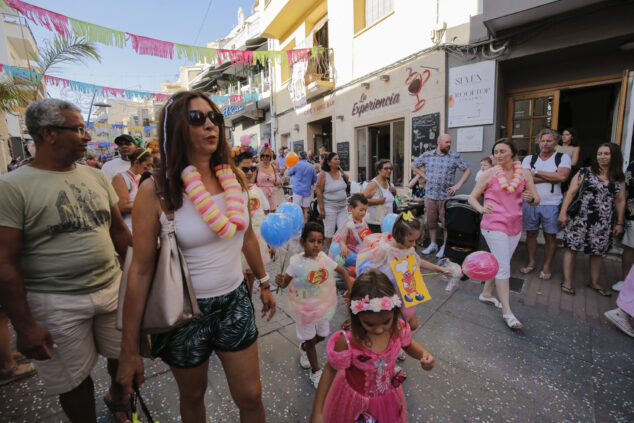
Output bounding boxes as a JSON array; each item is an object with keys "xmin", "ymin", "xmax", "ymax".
[{"xmin": 161, "ymin": 192, "xmax": 249, "ymax": 298}]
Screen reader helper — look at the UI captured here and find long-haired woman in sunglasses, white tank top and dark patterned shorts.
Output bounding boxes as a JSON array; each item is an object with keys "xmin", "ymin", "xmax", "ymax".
[{"xmin": 117, "ymin": 91, "xmax": 275, "ymax": 422}]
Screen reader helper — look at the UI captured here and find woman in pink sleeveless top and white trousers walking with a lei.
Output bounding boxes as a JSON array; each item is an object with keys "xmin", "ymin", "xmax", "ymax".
[{"xmin": 469, "ymin": 138, "xmax": 539, "ymax": 329}]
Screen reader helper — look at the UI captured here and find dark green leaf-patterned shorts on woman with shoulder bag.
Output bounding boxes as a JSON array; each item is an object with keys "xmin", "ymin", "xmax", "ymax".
[{"xmin": 152, "ymin": 281, "xmax": 258, "ymax": 368}]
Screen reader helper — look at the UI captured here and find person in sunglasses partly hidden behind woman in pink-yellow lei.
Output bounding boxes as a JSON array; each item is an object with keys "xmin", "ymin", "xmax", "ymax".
[{"xmin": 231, "ymin": 146, "xmax": 275, "ymax": 292}]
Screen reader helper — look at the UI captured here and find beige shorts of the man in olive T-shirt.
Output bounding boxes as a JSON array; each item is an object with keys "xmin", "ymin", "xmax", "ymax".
[{"xmin": 26, "ymin": 277, "xmax": 121, "ymax": 395}]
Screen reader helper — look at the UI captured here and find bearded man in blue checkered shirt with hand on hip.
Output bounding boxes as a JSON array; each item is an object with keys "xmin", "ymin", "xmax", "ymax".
[{"xmin": 414, "ymin": 134, "xmax": 471, "ymax": 257}]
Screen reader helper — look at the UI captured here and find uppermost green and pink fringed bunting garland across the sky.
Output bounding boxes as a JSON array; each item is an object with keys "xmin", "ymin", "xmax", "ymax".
[{"xmin": 0, "ymin": 0, "xmax": 319, "ymax": 66}]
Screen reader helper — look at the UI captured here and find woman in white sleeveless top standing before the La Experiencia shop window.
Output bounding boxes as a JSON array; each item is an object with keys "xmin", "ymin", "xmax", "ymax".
[{"xmin": 363, "ymin": 159, "xmax": 396, "ymax": 233}]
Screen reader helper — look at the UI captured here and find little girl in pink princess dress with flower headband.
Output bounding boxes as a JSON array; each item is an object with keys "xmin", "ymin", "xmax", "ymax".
[{"xmin": 311, "ymin": 270, "xmax": 435, "ymax": 423}]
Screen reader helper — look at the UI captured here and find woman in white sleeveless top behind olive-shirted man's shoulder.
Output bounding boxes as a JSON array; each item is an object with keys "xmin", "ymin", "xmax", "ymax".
[{"xmin": 112, "ymin": 148, "xmax": 153, "ymax": 232}]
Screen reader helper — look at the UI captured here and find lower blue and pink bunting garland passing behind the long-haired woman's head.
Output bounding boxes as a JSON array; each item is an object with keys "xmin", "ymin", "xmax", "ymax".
[{"xmin": 0, "ymin": 64, "xmax": 262, "ymax": 106}]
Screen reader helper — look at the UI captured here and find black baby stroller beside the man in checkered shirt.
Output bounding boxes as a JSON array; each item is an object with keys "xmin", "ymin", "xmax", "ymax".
[{"xmin": 445, "ymin": 194, "xmax": 480, "ymax": 264}]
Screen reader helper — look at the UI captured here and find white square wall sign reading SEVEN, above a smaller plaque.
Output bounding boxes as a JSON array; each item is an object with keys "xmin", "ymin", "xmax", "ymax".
[{"xmin": 448, "ymin": 60, "xmax": 495, "ymax": 128}]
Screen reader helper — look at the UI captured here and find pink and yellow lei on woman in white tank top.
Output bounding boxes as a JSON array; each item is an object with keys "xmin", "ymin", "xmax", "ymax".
[{"xmin": 181, "ymin": 165, "xmax": 247, "ymax": 239}]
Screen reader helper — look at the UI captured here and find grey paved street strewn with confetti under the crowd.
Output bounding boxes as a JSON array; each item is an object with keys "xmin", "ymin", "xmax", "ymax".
[{"xmin": 0, "ymin": 244, "xmax": 634, "ymax": 423}]
